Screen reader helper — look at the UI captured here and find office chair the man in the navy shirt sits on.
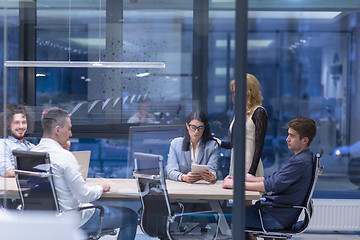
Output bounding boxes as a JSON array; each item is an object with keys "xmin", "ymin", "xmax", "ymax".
[{"xmin": 245, "ymin": 150, "xmax": 323, "ymax": 239}]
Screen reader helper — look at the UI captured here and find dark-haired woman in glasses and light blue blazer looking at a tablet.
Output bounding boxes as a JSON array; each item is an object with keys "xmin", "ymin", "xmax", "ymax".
[{"xmin": 166, "ymin": 111, "xmax": 218, "ymax": 183}]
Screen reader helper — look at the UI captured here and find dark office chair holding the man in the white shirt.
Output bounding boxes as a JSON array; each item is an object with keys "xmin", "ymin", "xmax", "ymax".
[{"xmin": 13, "ymin": 150, "xmax": 116, "ymax": 240}]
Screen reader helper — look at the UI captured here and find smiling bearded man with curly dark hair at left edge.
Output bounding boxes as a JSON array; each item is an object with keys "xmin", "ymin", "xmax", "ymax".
[{"xmin": 0, "ymin": 103, "xmax": 34, "ymax": 177}]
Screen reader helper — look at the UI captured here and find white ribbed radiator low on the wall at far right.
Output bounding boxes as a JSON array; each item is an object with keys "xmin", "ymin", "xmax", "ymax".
[{"xmin": 308, "ymin": 199, "xmax": 360, "ymax": 231}]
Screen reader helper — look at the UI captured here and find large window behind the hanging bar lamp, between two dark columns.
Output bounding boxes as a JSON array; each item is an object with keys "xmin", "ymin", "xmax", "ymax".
[{"xmin": 35, "ymin": 1, "xmax": 192, "ymax": 123}]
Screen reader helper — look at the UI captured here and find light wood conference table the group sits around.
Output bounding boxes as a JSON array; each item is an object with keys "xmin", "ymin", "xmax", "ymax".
[{"xmin": 0, "ymin": 177, "xmax": 260, "ymax": 235}]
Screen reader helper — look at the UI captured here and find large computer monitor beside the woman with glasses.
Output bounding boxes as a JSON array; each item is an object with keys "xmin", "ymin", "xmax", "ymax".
[{"xmin": 127, "ymin": 125, "xmax": 185, "ymax": 178}]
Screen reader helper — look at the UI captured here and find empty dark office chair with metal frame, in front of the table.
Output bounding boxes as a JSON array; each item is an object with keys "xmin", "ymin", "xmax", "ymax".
[{"xmin": 133, "ymin": 152, "xmax": 220, "ymax": 240}]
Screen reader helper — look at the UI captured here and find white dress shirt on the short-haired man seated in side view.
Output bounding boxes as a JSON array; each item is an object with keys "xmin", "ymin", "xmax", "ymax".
[{"xmin": 31, "ymin": 138, "xmax": 103, "ymax": 226}]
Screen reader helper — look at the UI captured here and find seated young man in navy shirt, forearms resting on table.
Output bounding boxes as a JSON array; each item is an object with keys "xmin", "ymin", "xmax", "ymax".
[{"xmin": 245, "ymin": 117, "xmax": 316, "ymax": 233}]
